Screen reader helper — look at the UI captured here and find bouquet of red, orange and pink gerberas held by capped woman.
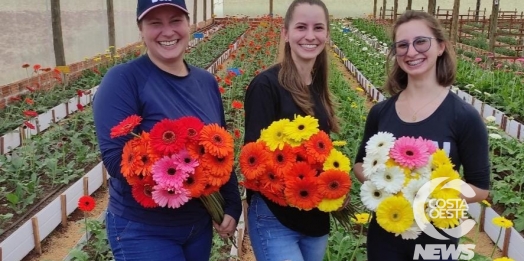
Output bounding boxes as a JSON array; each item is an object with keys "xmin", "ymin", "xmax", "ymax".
[{"xmin": 111, "ymin": 115, "xmax": 234, "ymax": 224}]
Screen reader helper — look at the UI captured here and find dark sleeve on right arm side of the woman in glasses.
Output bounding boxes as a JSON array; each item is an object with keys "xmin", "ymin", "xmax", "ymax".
[{"xmin": 457, "ymin": 104, "xmax": 490, "ymax": 189}]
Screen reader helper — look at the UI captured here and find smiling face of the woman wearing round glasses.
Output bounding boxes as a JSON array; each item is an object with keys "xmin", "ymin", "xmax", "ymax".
[{"xmin": 394, "ymin": 20, "xmax": 445, "ymax": 78}]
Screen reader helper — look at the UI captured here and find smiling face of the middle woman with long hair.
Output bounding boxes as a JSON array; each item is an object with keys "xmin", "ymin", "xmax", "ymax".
[{"xmin": 283, "ymin": 4, "xmax": 328, "ymax": 62}]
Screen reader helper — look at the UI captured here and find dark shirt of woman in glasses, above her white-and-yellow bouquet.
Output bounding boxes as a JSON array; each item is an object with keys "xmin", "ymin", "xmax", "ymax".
[{"xmin": 355, "ymin": 92, "xmax": 490, "ymax": 189}]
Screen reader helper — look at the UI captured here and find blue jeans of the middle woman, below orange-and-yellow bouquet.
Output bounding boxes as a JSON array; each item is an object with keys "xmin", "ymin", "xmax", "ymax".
[{"xmin": 248, "ymin": 193, "xmax": 328, "ymax": 261}]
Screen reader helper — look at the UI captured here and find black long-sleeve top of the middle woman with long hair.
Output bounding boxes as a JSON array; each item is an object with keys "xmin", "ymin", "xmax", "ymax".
[{"xmin": 244, "ymin": 65, "xmax": 330, "ymax": 236}]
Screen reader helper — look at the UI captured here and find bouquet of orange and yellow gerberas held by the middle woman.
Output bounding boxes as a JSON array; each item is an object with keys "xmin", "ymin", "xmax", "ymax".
[{"xmin": 240, "ymin": 116, "xmax": 351, "ymax": 228}]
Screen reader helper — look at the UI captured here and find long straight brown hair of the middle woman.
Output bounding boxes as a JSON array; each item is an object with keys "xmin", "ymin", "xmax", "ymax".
[{"xmin": 278, "ymin": 0, "xmax": 340, "ymax": 132}]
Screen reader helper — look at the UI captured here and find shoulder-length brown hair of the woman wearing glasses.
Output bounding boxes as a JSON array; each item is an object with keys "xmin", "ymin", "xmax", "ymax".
[{"xmin": 384, "ymin": 10, "xmax": 457, "ymax": 96}]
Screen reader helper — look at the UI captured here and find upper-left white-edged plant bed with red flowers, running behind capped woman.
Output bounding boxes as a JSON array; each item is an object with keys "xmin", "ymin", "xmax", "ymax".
[{"xmin": 0, "ymin": 24, "xmax": 227, "ymax": 155}]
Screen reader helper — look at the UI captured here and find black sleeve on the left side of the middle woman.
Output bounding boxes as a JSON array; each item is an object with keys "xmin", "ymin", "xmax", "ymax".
[{"xmin": 244, "ymin": 75, "xmax": 278, "ymax": 144}]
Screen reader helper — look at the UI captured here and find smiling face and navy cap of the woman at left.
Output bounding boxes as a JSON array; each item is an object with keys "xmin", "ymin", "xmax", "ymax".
[{"xmin": 139, "ymin": 6, "xmax": 189, "ymax": 64}]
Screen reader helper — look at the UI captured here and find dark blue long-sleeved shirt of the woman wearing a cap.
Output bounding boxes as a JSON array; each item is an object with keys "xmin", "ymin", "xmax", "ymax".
[{"xmin": 93, "ymin": 55, "xmax": 242, "ymax": 226}]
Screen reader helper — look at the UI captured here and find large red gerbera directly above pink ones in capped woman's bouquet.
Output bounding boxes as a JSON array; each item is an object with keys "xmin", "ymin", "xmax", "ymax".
[{"xmin": 150, "ymin": 119, "xmax": 187, "ymax": 155}]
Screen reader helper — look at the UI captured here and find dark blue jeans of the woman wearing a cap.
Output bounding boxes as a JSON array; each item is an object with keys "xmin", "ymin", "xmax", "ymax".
[{"xmin": 106, "ymin": 211, "xmax": 213, "ymax": 261}]
